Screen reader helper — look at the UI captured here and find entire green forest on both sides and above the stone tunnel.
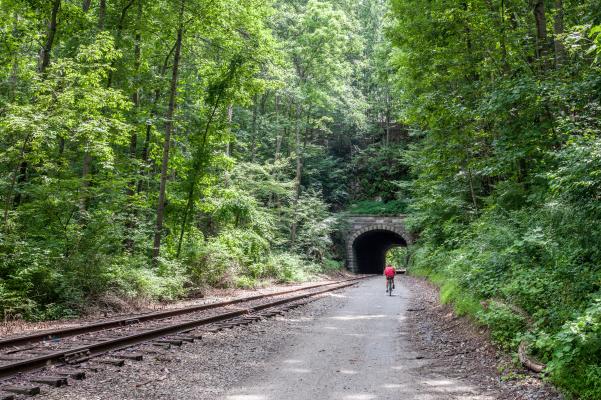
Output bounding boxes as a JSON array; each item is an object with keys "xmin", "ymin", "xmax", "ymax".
[{"xmin": 0, "ymin": 0, "xmax": 601, "ymax": 399}]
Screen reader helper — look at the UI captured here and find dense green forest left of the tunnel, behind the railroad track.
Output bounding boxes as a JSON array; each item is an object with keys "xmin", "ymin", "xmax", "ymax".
[{"xmin": 0, "ymin": 0, "xmax": 398, "ymax": 320}]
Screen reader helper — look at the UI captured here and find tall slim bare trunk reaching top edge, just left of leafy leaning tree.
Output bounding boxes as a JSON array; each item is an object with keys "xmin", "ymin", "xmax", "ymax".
[{"xmin": 152, "ymin": 0, "xmax": 185, "ymax": 264}]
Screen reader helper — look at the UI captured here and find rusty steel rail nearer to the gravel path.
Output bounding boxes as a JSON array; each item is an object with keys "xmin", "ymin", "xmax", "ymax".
[{"xmin": 0, "ymin": 277, "xmax": 366, "ymax": 378}]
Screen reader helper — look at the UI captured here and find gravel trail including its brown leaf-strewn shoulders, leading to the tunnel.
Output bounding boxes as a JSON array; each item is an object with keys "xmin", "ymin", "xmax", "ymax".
[{"xmin": 42, "ymin": 277, "xmax": 560, "ymax": 400}]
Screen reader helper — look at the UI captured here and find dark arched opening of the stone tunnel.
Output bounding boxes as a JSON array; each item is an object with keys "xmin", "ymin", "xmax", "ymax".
[{"xmin": 353, "ymin": 230, "xmax": 407, "ymax": 274}]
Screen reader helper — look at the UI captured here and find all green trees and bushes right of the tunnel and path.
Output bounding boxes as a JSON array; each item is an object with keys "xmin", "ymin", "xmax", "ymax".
[{"xmin": 387, "ymin": 0, "xmax": 601, "ymax": 399}]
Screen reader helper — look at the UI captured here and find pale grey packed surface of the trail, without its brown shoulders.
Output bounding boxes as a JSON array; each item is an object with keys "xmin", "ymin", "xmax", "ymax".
[{"xmin": 222, "ymin": 277, "xmax": 498, "ymax": 400}]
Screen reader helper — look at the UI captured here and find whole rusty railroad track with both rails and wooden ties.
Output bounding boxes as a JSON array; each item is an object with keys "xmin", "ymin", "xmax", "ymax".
[{"xmin": 0, "ymin": 277, "xmax": 366, "ymax": 400}]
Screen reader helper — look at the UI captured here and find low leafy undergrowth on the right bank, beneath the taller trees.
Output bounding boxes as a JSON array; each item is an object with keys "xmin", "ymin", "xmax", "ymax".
[{"xmin": 410, "ymin": 199, "xmax": 601, "ymax": 400}]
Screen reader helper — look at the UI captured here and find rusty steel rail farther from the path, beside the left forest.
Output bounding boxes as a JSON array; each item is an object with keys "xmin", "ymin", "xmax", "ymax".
[{"xmin": 0, "ymin": 277, "xmax": 365, "ymax": 349}]
